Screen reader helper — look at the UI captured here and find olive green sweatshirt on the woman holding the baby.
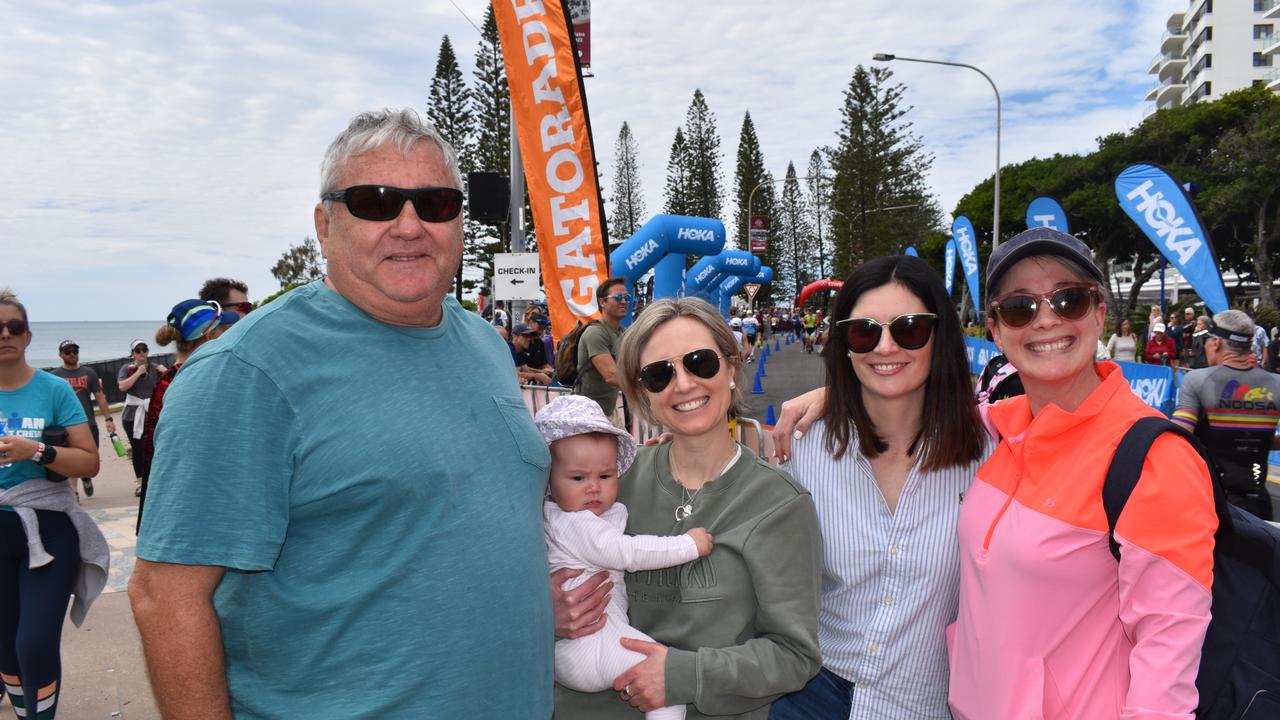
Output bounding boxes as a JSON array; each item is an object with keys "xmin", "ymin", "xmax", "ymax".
[{"xmin": 556, "ymin": 445, "xmax": 822, "ymax": 720}]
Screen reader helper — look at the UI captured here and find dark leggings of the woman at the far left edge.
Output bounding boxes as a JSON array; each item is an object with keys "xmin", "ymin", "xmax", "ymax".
[{"xmin": 0, "ymin": 510, "xmax": 81, "ymax": 720}]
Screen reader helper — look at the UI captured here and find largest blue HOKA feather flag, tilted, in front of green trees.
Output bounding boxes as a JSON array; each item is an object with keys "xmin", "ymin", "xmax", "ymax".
[{"xmin": 1116, "ymin": 163, "xmax": 1226, "ymax": 313}]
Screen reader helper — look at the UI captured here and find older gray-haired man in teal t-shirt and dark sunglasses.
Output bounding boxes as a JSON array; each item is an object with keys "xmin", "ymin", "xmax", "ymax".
[{"xmin": 129, "ymin": 110, "xmax": 553, "ymax": 720}]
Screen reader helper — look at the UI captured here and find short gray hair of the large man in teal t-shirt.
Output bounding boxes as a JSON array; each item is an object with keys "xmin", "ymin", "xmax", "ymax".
[{"xmin": 320, "ymin": 108, "xmax": 462, "ymax": 196}]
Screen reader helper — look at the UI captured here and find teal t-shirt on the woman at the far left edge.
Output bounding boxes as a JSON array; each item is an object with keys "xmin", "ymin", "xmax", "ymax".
[{"xmin": 0, "ymin": 370, "xmax": 88, "ymax": 489}]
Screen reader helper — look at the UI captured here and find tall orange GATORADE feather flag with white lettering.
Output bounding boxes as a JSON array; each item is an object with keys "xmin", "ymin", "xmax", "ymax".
[{"xmin": 493, "ymin": 0, "xmax": 608, "ymax": 340}]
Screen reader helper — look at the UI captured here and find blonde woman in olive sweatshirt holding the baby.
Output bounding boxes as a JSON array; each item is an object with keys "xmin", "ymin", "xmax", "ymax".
[{"xmin": 552, "ymin": 297, "xmax": 822, "ymax": 720}]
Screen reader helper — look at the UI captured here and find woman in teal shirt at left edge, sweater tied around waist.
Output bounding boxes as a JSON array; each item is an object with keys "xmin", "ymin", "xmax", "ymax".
[{"xmin": 0, "ymin": 288, "xmax": 110, "ymax": 717}]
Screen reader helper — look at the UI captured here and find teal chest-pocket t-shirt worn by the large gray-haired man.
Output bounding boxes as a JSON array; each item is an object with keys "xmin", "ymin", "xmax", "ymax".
[{"xmin": 140, "ymin": 282, "xmax": 554, "ymax": 720}]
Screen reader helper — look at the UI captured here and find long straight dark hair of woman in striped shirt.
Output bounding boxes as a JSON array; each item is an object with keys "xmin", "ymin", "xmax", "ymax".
[{"xmin": 822, "ymin": 255, "xmax": 983, "ymax": 470}]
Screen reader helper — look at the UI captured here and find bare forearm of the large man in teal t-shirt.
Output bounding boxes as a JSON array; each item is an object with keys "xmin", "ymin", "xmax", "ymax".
[{"xmin": 129, "ymin": 557, "xmax": 232, "ymax": 720}]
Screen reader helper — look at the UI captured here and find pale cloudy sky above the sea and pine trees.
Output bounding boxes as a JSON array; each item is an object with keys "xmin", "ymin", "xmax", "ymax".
[{"xmin": 0, "ymin": 0, "xmax": 1187, "ymax": 320}]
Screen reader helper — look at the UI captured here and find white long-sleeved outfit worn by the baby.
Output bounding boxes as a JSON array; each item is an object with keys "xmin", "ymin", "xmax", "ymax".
[{"xmin": 543, "ymin": 501, "xmax": 698, "ymax": 720}]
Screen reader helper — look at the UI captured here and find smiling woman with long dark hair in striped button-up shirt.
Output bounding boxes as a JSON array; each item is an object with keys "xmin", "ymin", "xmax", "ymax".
[{"xmin": 771, "ymin": 255, "xmax": 995, "ymax": 720}]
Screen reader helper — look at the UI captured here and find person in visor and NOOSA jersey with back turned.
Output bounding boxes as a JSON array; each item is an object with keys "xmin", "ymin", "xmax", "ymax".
[{"xmin": 1172, "ymin": 304, "xmax": 1280, "ymax": 520}]
